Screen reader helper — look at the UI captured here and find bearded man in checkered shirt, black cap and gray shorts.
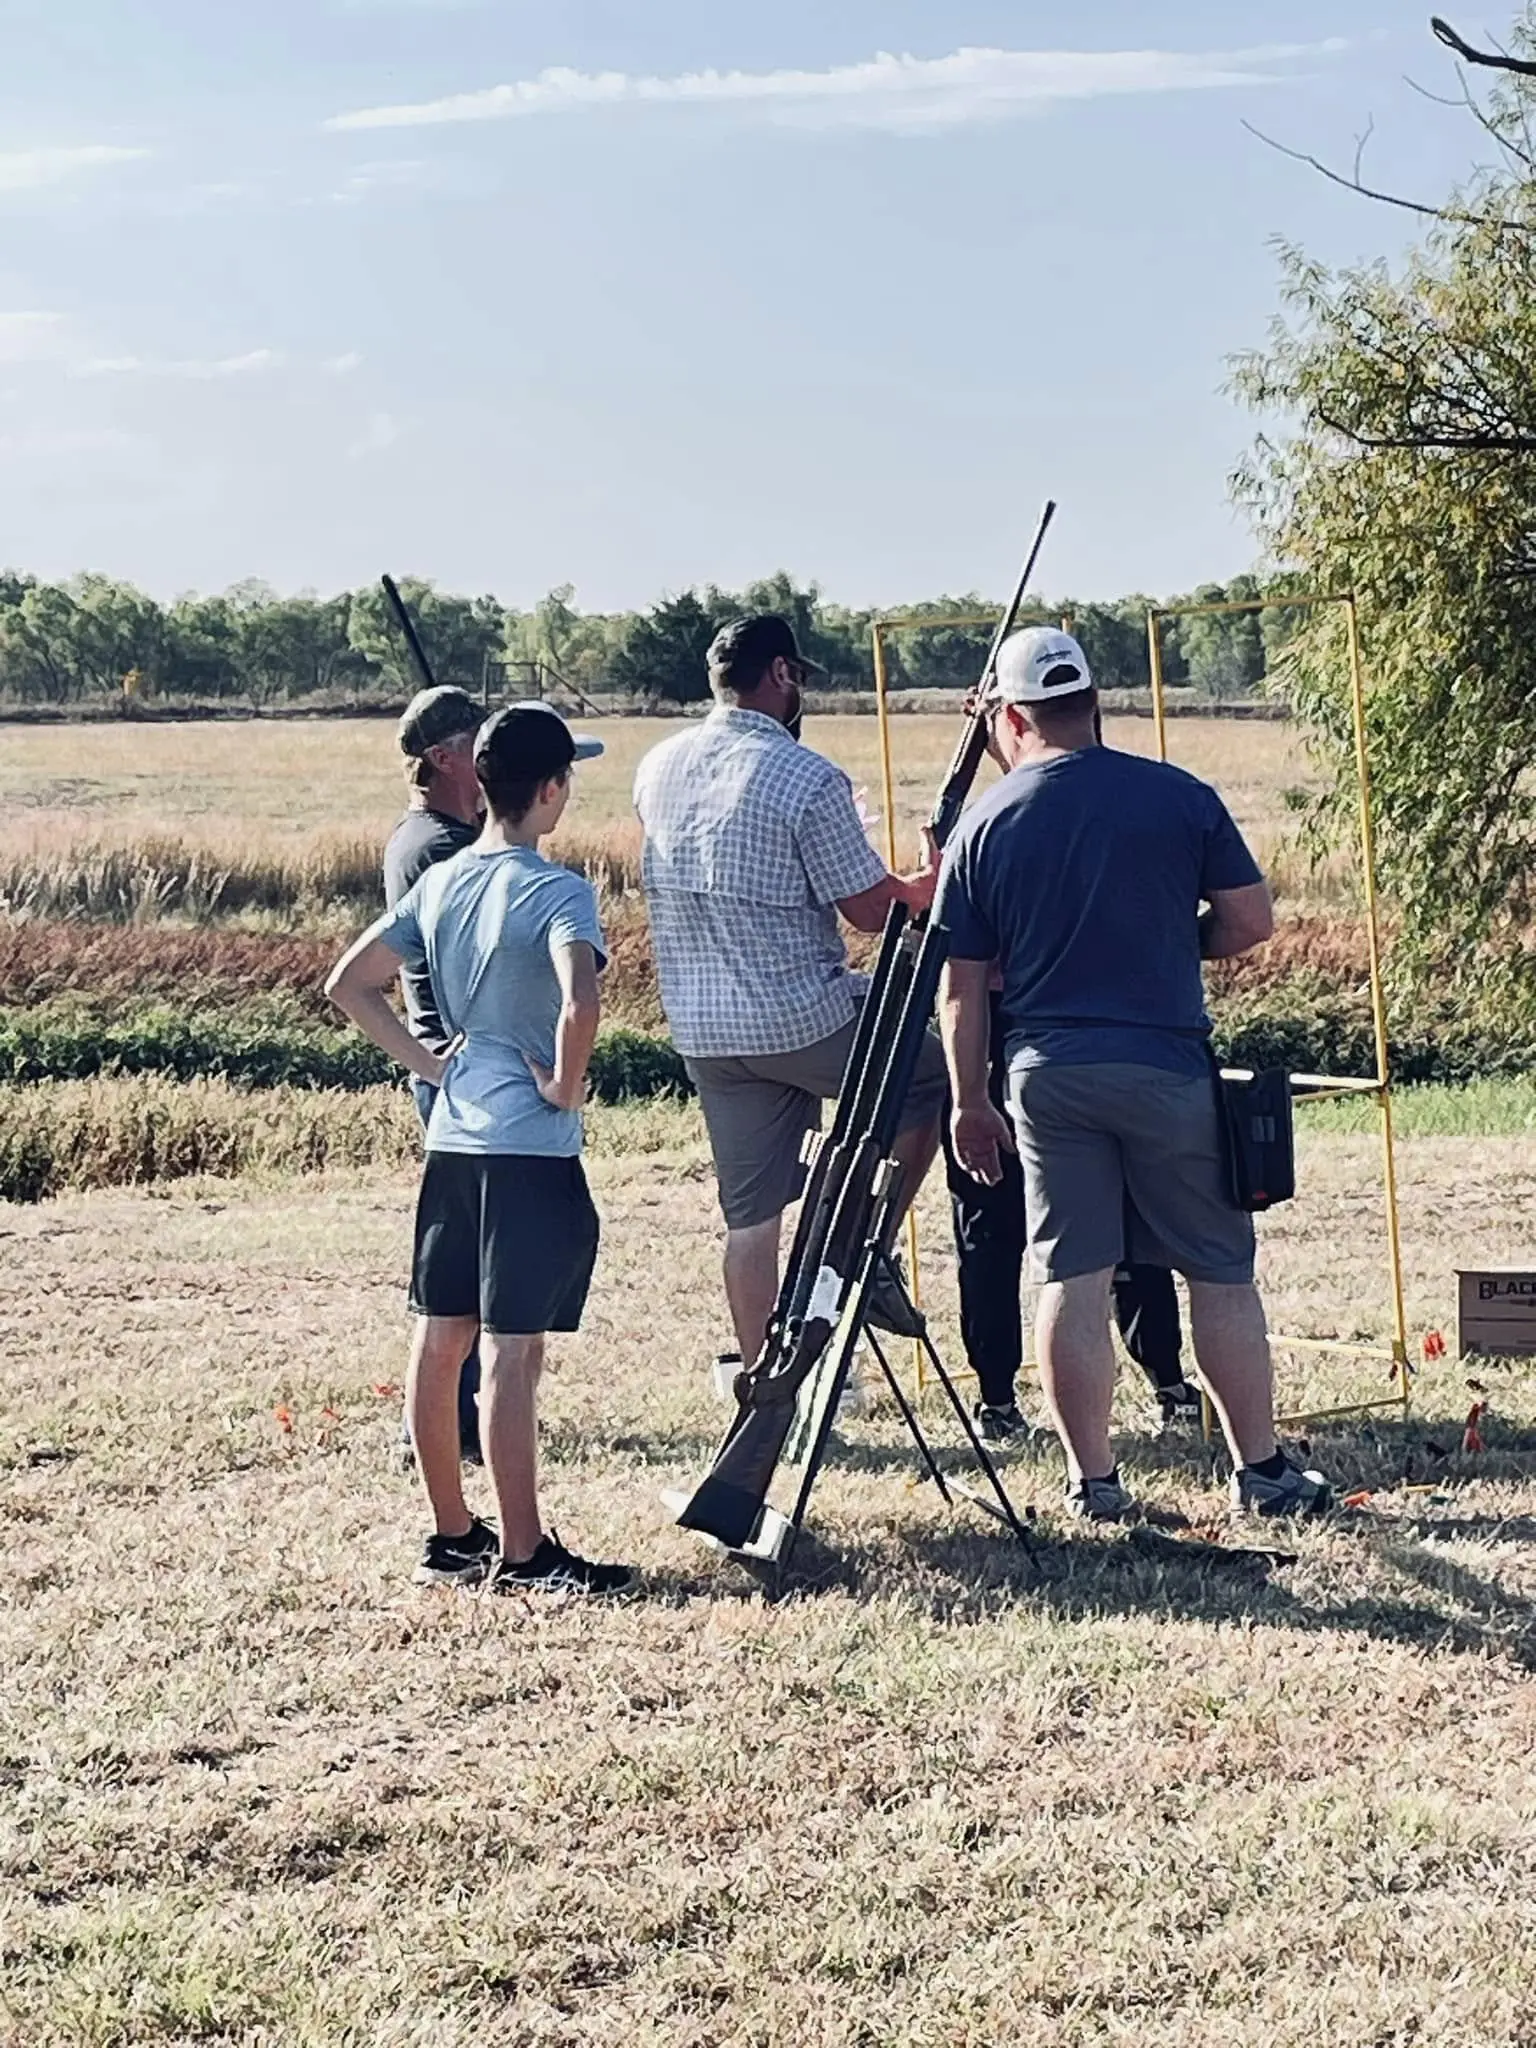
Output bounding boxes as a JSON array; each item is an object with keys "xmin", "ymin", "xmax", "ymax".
[{"xmin": 635, "ymin": 612, "xmax": 944, "ymax": 1360}]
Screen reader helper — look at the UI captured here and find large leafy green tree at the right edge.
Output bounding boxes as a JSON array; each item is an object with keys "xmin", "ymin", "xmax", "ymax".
[{"xmin": 1237, "ymin": 12, "xmax": 1536, "ymax": 1001}]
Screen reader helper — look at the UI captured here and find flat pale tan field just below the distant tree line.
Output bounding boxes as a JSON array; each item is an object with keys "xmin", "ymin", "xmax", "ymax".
[{"xmin": 0, "ymin": 713, "xmax": 1315, "ymax": 892}]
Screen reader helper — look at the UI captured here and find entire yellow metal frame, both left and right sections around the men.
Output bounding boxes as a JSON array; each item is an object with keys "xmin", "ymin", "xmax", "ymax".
[{"xmin": 872, "ymin": 592, "xmax": 1411, "ymax": 1436}]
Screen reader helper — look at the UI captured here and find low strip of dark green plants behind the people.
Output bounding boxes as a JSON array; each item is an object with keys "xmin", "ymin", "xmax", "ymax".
[{"xmin": 0, "ymin": 999, "xmax": 1536, "ymax": 1102}]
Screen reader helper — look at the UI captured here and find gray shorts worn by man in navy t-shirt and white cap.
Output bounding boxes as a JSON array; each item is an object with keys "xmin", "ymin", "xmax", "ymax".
[{"xmin": 1008, "ymin": 1065, "xmax": 1253, "ymax": 1286}]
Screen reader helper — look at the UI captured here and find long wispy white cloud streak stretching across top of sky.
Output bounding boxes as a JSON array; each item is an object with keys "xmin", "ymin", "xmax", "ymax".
[{"xmin": 326, "ymin": 39, "xmax": 1348, "ymax": 133}]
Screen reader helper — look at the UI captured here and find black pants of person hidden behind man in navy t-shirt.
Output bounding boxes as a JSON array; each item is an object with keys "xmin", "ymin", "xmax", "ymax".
[{"xmin": 942, "ymin": 997, "xmax": 1184, "ymax": 1407}]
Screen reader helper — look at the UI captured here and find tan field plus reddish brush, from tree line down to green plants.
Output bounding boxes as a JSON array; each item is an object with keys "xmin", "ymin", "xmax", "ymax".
[{"xmin": 0, "ymin": 715, "xmax": 1364, "ymax": 1030}]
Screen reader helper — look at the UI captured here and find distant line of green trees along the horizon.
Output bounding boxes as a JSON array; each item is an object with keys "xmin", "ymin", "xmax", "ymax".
[{"xmin": 0, "ymin": 571, "xmax": 1284, "ymax": 707}]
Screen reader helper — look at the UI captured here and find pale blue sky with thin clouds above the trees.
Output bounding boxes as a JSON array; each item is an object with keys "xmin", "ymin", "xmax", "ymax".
[{"xmin": 0, "ymin": 0, "xmax": 1507, "ymax": 608}]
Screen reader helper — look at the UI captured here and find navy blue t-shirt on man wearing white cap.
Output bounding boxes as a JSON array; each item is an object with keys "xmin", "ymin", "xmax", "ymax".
[{"xmin": 934, "ymin": 748, "xmax": 1264, "ymax": 1073}]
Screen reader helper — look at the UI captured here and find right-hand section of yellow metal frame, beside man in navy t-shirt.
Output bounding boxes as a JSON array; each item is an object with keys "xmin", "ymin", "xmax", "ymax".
[{"xmin": 1147, "ymin": 592, "xmax": 1413, "ymax": 1436}]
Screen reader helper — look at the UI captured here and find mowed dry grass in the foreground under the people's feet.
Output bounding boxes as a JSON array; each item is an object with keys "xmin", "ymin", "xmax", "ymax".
[{"xmin": 0, "ymin": 1108, "xmax": 1536, "ymax": 2048}]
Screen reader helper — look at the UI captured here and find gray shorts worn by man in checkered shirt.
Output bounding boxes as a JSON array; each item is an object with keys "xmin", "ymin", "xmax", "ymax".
[{"xmin": 684, "ymin": 1018, "xmax": 946, "ymax": 1231}]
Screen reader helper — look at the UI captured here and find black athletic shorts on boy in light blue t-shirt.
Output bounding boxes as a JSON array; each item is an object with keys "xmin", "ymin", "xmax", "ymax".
[{"xmin": 412, "ymin": 1151, "xmax": 598, "ymax": 1337}]
